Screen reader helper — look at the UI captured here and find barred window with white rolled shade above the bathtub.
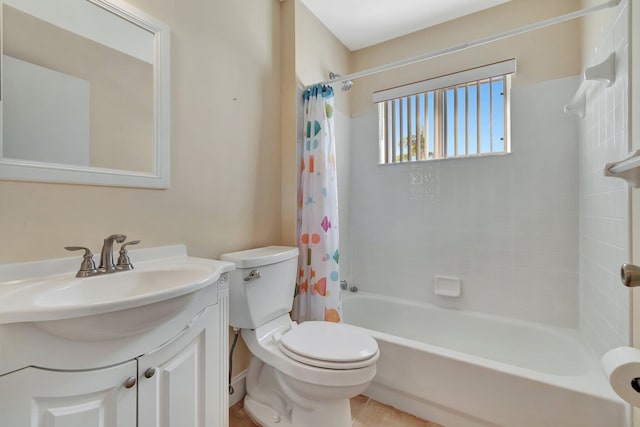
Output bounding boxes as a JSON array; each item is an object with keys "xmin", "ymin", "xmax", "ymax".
[{"xmin": 374, "ymin": 60, "xmax": 515, "ymax": 163}]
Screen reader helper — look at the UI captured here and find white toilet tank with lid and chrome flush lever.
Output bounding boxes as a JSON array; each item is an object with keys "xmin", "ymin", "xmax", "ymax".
[{"xmin": 220, "ymin": 246, "xmax": 298, "ymax": 329}]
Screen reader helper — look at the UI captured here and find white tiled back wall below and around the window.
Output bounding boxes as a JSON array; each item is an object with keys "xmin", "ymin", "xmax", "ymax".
[{"xmin": 348, "ymin": 78, "xmax": 579, "ymax": 327}]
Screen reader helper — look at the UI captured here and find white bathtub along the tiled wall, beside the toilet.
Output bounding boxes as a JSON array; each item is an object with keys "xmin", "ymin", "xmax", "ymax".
[{"xmin": 343, "ymin": 292, "xmax": 630, "ymax": 427}]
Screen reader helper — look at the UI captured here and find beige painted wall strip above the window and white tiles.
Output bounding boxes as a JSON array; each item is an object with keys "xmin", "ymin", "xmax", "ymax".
[{"xmin": 351, "ymin": 0, "xmax": 581, "ymax": 116}]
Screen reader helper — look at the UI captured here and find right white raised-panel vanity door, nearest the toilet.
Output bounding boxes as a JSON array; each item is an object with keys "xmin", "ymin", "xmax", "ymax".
[{"xmin": 138, "ymin": 306, "xmax": 223, "ymax": 427}]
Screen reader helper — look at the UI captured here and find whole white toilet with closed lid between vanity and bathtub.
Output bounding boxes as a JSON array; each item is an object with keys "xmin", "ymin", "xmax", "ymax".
[{"xmin": 221, "ymin": 246, "xmax": 379, "ymax": 427}]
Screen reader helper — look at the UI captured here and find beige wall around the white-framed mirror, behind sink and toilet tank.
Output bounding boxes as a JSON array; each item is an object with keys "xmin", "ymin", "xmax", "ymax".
[{"xmin": 0, "ymin": 0, "xmax": 281, "ymax": 263}]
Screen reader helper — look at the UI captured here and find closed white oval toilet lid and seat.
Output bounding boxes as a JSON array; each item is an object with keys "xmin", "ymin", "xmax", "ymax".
[{"xmin": 280, "ymin": 321, "xmax": 378, "ymax": 369}]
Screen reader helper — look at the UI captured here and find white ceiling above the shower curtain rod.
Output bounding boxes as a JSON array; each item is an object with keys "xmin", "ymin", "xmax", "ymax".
[{"xmin": 301, "ymin": 0, "xmax": 509, "ymax": 51}]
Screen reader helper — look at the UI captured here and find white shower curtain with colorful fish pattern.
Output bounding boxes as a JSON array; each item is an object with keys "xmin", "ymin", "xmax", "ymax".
[{"xmin": 292, "ymin": 85, "xmax": 342, "ymax": 322}]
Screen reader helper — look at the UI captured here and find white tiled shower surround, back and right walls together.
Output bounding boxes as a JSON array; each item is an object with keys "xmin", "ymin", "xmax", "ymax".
[{"xmin": 330, "ymin": 1, "xmax": 630, "ymax": 340}]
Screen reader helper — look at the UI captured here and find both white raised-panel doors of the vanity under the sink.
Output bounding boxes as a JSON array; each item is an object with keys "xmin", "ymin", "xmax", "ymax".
[{"xmin": 0, "ymin": 304, "xmax": 228, "ymax": 427}]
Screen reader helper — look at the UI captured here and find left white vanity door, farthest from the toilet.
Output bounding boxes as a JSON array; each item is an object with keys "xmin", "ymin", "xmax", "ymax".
[{"xmin": 0, "ymin": 360, "xmax": 137, "ymax": 427}]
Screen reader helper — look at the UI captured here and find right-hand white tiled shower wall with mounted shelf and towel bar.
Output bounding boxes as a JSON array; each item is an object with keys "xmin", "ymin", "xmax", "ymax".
[{"xmin": 579, "ymin": 5, "xmax": 630, "ymax": 356}]
